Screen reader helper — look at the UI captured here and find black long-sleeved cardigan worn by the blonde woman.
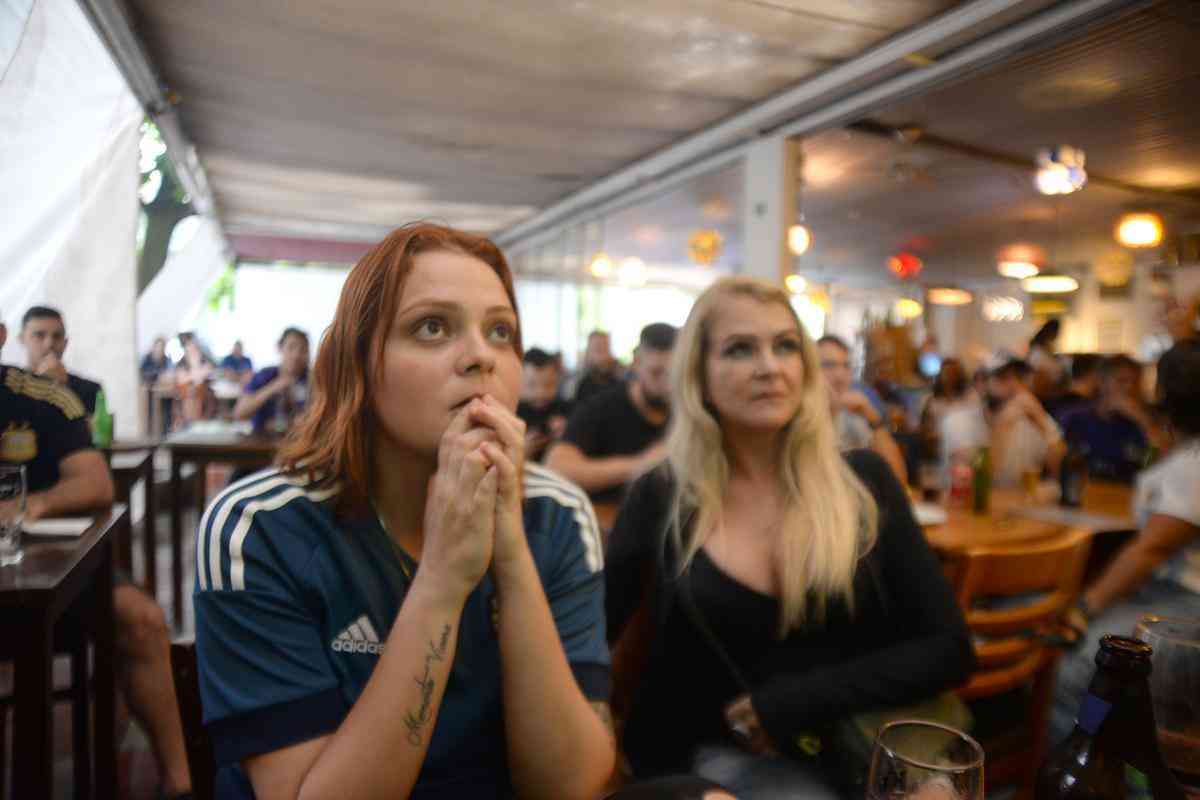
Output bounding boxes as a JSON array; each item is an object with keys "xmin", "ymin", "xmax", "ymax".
[{"xmin": 605, "ymin": 450, "xmax": 974, "ymax": 776}]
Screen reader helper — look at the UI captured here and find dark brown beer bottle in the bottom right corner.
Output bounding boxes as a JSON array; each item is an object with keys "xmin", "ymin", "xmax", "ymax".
[{"xmin": 1034, "ymin": 636, "xmax": 1186, "ymax": 800}]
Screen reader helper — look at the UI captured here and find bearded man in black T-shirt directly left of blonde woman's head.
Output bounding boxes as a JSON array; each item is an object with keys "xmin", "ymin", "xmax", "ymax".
[{"xmin": 546, "ymin": 323, "xmax": 676, "ymax": 503}]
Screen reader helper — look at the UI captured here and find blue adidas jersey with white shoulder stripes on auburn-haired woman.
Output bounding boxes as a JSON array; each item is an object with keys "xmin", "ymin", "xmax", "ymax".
[{"xmin": 196, "ymin": 464, "xmax": 610, "ymax": 798}]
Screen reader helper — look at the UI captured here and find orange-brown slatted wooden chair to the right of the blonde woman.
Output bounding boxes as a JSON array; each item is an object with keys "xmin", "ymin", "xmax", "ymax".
[{"xmin": 958, "ymin": 530, "xmax": 1091, "ymax": 796}]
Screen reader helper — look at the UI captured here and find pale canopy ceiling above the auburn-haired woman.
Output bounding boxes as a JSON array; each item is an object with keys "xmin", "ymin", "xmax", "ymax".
[{"xmin": 130, "ymin": 0, "xmax": 974, "ymax": 247}]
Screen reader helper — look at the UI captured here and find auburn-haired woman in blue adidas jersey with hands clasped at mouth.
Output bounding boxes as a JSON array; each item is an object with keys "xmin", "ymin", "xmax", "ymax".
[{"xmin": 196, "ymin": 224, "xmax": 614, "ymax": 799}]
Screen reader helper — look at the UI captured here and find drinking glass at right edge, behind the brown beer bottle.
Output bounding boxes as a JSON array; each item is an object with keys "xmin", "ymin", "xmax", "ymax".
[{"xmin": 1133, "ymin": 614, "xmax": 1200, "ymax": 798}]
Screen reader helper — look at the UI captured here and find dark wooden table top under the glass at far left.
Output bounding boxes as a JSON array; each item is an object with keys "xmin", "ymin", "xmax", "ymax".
[{"xmin": 0, "ymin": 504, "xmax": 128, "ymax": 607}]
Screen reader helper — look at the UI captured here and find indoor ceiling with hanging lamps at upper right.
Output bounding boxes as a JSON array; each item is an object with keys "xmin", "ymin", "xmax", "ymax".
[{"xmin": 539, "ymin": 0, "xmax": 1200, "ymax": 285}]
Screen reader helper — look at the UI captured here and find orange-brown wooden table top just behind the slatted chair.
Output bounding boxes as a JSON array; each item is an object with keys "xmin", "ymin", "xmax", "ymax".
[{"xmin": 925, "ymin": 483, "xmax": 1135, "ymax": 552}]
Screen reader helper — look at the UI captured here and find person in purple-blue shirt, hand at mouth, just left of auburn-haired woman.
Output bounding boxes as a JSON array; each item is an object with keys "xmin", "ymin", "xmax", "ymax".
[{"xmin": 233, "ymin": 327, "xmax": 308, "ymax": 435}]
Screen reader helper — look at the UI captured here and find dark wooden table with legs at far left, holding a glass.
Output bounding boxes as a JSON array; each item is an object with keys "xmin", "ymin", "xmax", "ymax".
[{"xmin": 0, "ymin": 505, "xmax": 130, "ymax": 798}]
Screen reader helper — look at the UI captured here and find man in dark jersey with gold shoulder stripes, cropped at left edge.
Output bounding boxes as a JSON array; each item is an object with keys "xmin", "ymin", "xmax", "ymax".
[{"xmin": 0, "ymin": 324, "xmax": 192, "ymax": 796}]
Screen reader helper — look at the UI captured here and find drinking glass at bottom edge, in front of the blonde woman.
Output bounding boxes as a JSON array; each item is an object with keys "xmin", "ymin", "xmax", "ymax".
[{"xmin": 866, "ymin": 720, "xmax": 983, "ymax": 800}]
